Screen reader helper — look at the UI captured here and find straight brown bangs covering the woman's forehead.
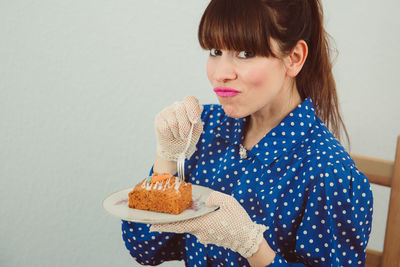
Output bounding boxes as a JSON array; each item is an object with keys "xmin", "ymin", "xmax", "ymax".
[{"xmin": 198, "ymin": 0, "xmax": 274, "ymax": 57}]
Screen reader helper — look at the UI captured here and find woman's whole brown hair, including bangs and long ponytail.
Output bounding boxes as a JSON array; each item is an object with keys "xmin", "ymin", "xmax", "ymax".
[{"xmin": 198, "ymin": 0, "xmax": 349, "ymax": 144}]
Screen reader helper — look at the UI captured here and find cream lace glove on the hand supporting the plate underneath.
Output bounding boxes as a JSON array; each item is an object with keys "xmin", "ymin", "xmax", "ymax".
[{"xmin": 150, "ymin": 191, "xmax": 266, "ymax": 258}]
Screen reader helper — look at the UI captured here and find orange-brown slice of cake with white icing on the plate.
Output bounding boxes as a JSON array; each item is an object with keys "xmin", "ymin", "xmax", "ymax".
[{"xmin": 129, "ymin": 173, "xmax": 193, "ymax": 214}]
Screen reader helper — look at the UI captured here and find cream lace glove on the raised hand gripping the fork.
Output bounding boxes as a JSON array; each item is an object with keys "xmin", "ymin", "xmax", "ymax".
[{"xmin": 154, "ymin": 96, "xmax": 203, "ymax": 161}]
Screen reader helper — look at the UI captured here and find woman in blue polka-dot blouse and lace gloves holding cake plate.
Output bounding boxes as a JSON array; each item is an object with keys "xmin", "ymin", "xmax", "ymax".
[{"xmin": 122, "ymin": 0, "xmax": 372, "ymax": 266}]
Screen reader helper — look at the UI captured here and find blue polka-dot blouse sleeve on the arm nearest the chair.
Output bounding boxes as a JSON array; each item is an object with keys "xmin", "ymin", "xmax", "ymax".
[{"xmin": 270, "ymin": 165, "xmax": 373, "ymax": 266}]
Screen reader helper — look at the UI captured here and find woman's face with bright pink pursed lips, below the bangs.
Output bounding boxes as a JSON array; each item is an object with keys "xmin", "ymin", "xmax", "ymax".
[{"xmin": 207, "ymin": 42, "xmax": 293, "ymax": 118}]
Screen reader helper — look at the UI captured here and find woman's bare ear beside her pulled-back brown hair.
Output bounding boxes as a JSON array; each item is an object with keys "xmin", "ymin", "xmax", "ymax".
[{"xmin": 286, "ymin": 40, "xmax": 308, "ymax": 78}]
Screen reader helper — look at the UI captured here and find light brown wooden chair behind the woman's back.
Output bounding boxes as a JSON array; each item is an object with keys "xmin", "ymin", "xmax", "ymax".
[{"xmin": 351, "ymin": 135, "xmax": 400, "ymax": 267}]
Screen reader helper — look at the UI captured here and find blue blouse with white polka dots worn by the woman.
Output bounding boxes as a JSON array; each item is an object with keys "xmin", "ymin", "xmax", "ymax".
[{"xmin": 122, "ymin": 99, "xmax": 373, "ymax": 266}]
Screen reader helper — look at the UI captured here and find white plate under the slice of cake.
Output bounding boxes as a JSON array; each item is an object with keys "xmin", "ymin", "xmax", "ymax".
[{"xmin": 103, "ymin": 184, "xmax": 219, "ymax": 224}]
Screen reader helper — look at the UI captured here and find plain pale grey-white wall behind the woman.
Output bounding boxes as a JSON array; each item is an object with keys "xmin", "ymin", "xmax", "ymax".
[{"xmin": 0, "ymin": 0, "xmax": 400, "ymax": 267}]
